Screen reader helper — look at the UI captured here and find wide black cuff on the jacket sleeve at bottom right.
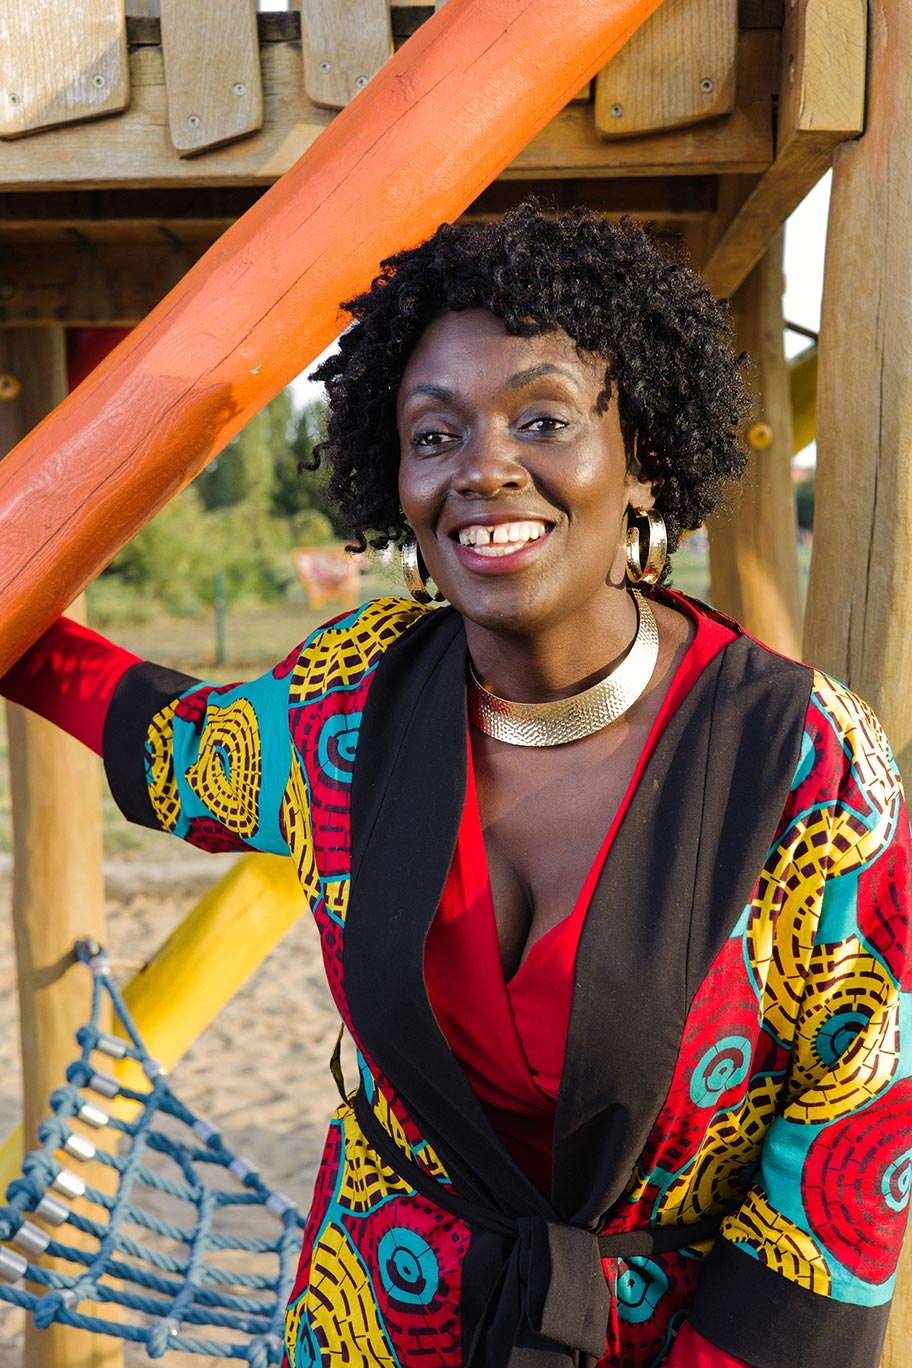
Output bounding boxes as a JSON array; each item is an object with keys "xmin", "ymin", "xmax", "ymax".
[{"xmin": 690, "ymin": 1239, "xmax": 890, "ymax": 1368}]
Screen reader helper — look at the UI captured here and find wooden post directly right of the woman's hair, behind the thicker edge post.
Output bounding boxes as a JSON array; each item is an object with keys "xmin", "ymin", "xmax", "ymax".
[{"xmin": 710, "ymin": 231, "xmax": 801, "ymax": 657}]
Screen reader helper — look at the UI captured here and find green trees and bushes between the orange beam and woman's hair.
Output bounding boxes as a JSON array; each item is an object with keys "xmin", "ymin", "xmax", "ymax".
[{"xmin": 94, "ymin": 393, "xmax": 340, "ymax": 621}]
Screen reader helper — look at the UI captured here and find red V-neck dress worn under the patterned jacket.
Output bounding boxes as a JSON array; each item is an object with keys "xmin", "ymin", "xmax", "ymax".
[{"xmin": 424, "ymin": 596, "xmax": 745, "ymax": 1368}]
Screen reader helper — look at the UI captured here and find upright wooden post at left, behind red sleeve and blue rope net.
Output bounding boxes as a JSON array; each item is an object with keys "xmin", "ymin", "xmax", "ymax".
[{"xmin": 0, "ymin": 328, "xmax": 122, "ymax": 1368}]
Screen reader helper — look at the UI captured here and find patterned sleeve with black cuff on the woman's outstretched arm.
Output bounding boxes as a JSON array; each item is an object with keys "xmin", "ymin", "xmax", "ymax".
[{"xmin": 104, "ymin": 647, "xmax": 301, "ymax": 855}]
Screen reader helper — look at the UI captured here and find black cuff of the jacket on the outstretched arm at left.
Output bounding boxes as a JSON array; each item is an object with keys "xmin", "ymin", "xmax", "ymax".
[{"xmin": 101, "ymin": 661, "xmax": 200, "ymax": 832}]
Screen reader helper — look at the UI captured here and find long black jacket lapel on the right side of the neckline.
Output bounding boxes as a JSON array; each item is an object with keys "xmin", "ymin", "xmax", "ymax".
[{"xmin": 552, "ymin": 636, "xmax": 812, "ymax": 1224}]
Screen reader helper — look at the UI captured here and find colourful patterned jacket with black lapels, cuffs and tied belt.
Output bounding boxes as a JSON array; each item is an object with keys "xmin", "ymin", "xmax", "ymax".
[{"xmin": 105, "ymin": 599, "xmax": 912, "ymax": 1368}]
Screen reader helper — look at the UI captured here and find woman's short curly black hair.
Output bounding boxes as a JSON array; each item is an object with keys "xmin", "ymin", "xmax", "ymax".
[{"xmin": 314, "ymin": 198, "xmax": 748, "ymax": 566}]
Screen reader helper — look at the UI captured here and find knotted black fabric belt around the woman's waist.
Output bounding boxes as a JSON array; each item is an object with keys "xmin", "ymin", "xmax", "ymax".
[{"xmin": 353, "ymin": 1090, "xmax": 723, "ymax": 1368}]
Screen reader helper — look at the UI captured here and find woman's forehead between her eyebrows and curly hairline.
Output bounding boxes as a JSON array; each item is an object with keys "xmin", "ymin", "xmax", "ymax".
[{"xmin": 399, "ymin": 309, "xmax": 604, "ymax": 402}]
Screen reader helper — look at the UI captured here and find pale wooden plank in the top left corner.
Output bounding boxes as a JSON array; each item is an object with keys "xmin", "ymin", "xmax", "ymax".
[{"xmin": 0, "ymin": 0, "xmax": 130, "ymax": 138}]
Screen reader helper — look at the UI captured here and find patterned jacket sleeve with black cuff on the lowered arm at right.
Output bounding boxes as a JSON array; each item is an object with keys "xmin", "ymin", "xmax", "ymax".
[{"xmin": 692, "ymin": 674, "xmax": 912, "ymax": 1368}]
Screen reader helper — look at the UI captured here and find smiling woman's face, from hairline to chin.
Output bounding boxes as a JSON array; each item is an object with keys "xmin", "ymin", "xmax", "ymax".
[{"xmin": 397, "ymin": 309, "xmax": 652, "ymax": 632}]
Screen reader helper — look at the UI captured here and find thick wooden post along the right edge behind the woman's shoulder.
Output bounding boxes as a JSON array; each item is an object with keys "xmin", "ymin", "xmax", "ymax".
[{"xmin": 805, "ymin": 0, "xmax": 912, "ymax": 787}]
